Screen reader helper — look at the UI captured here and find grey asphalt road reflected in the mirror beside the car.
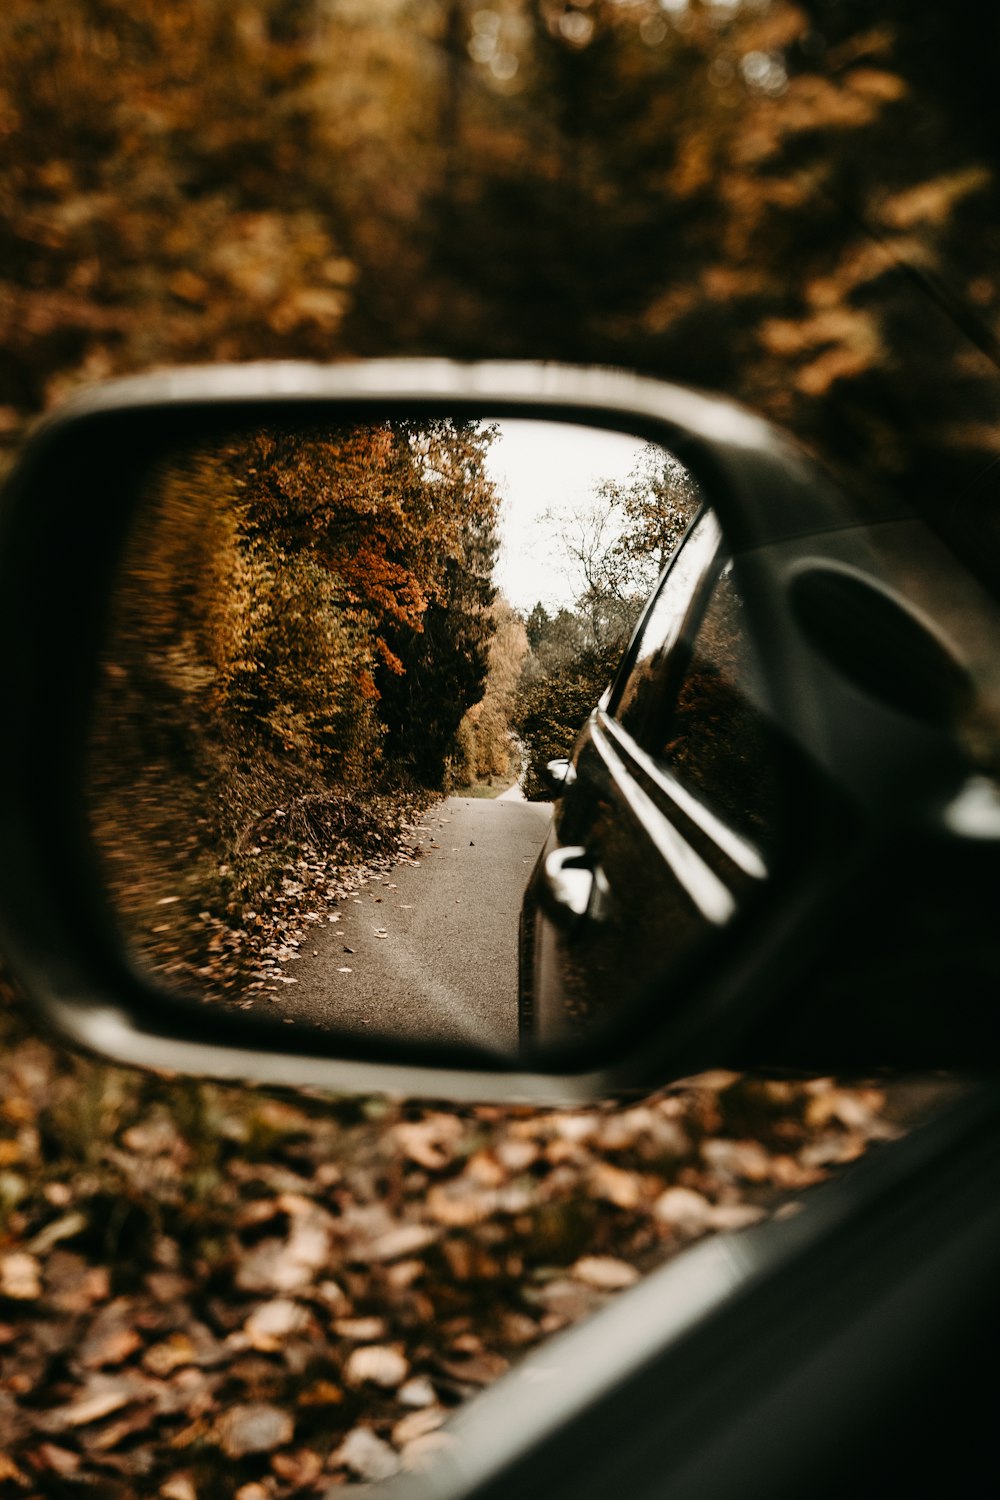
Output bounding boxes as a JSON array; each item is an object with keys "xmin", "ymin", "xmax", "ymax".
[{"xmin": 269, "ymin": 797, "xmax": 552, "ymax": 1053}]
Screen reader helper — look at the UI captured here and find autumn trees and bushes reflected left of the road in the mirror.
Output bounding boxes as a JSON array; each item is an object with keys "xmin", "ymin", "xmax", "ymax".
[{"xmin": 91, "ymin": 420, "xmax": 510, "ymax": 990}]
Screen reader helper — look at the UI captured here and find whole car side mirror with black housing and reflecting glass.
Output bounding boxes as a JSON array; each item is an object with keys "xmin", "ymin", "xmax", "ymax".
[{"xmin": 0, "ymin": 362, "xmax": 1000, "ymax": 1100}]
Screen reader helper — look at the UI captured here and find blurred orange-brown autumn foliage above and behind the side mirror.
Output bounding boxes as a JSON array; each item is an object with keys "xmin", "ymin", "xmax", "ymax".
[{"xmin": 0, "ymin": 0, "xmax": 1000, "ymax": 567}]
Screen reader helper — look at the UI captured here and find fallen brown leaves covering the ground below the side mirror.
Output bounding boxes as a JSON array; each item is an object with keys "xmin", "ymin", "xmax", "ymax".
[{"xmin": 0, "ymin": 990, "xmax": 959, "ymax": 1500}]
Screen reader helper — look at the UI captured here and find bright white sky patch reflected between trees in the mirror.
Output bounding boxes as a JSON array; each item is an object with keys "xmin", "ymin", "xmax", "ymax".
[{"xmin": 486, "ymin": 422, "xmax": 645, "ymax": 611}]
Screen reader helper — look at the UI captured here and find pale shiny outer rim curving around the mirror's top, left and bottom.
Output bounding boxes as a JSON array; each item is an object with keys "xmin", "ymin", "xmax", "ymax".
[{"xmin": 0, "ymin": 360, "xmax": 845, "ymax": 1104}]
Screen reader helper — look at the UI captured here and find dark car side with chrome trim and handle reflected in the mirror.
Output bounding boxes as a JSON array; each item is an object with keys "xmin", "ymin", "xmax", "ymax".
[{"xmin": 522, "ymin": 510, "xmax": 778, "ymax": 1046}]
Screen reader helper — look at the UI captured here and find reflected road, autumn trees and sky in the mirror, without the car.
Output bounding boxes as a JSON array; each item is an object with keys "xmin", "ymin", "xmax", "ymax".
[{"xmin": 87, "ymin": 419, "xmax": 710, "ymax": 1055}]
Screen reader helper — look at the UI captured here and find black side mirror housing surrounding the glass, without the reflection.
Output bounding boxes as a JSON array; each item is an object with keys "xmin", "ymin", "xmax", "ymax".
[{"xmin": 0, "ymin": 362, "xmax": 1000, "ymax": 1103}]
